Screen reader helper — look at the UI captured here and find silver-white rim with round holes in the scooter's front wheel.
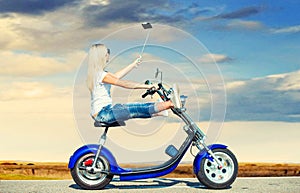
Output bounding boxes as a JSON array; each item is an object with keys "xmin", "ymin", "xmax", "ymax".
[{"xmin": 204, "ymin": 152, "xmax": 235, "ymax": 184}]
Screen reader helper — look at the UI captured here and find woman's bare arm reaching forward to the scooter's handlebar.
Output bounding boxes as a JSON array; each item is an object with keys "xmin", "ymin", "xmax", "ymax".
[{"xmin": 102, "ymin": 72, "xmax": 155, "ymax": 89}]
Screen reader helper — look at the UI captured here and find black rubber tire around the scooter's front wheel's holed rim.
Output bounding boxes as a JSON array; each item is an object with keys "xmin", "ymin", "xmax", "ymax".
[{"xmin": 196, "ymin": 149, "xmax": 238, "ymax": 189}]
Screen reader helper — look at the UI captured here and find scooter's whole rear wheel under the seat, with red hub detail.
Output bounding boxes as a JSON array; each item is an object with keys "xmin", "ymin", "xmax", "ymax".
[{"xmin": 71, "ymin": 153, "xmax": 113, "ymax": 190}]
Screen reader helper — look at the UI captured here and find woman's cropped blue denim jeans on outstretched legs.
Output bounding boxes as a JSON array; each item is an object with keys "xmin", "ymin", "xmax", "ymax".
[{"xmin": 95, "ymin": 103, "xmax": 158, "ymax": 124}]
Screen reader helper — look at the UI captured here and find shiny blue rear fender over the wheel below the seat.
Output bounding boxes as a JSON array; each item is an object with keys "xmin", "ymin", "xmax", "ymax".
[{"xmin": 68, "ymin": 144, "xmax": 124, "ymax": 174}]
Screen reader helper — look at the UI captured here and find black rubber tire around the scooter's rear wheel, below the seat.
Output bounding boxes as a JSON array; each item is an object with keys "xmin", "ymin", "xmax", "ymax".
[{"xmin": 70, "ymin": 153, "xmax": 113, "ymax": 190}]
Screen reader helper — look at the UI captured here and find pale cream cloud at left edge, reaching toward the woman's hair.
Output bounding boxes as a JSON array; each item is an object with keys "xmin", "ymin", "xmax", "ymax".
[{"xmin": 0, "ymin": 51, "xmax": 85, "ymax": 77}]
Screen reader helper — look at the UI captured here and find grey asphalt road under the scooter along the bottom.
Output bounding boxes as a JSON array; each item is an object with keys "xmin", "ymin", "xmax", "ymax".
[{"xmin": 0, "ymin": 177, "xmax": 300, "ymax": 193}]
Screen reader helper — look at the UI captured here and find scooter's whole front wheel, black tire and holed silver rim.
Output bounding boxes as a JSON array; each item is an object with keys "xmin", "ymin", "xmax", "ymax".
[{"xmin": 196, "ymin": 149, "xmax": 238, "ymax": 189}]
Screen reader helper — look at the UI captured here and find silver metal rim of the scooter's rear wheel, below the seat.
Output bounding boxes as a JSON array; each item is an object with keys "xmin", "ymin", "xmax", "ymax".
[{"xmin": 76, "ymin": 155, "xmax": 109, "ymax": 185}]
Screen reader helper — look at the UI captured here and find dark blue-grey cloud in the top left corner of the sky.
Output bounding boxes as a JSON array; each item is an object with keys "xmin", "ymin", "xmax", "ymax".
[{"xmin": 0, "ymin": 0, "xmax": 79, "ymax": 15}]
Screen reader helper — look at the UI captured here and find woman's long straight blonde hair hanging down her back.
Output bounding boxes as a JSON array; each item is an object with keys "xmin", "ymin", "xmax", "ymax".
[{"xmin": 86, "ymin": 44, "xmax": 107, "ymax": 92}]
